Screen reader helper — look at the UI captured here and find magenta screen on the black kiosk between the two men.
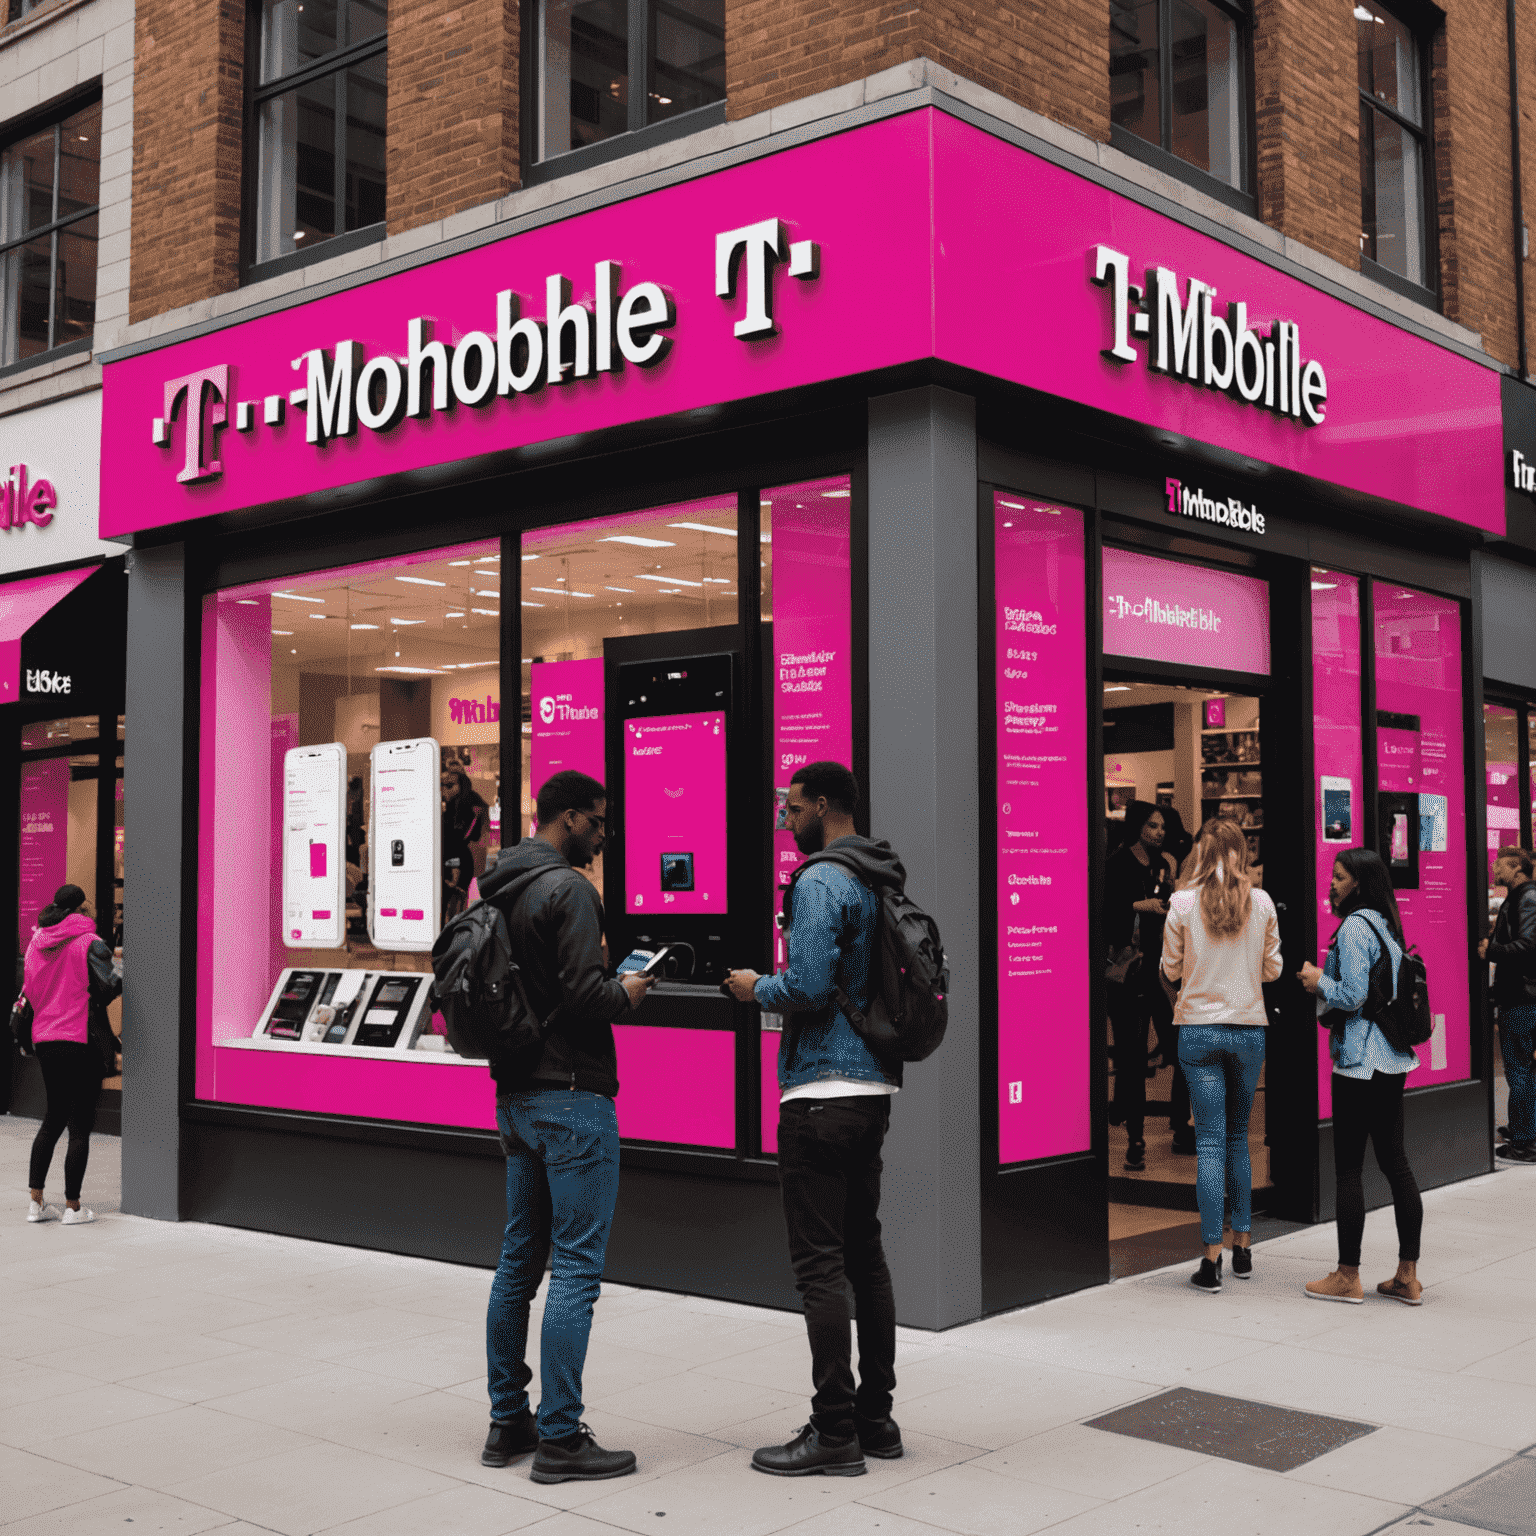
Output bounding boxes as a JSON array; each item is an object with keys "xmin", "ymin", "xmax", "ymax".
[{"xmin": 624, "ymin": 710, "xmax": 727, "ymax": 917}]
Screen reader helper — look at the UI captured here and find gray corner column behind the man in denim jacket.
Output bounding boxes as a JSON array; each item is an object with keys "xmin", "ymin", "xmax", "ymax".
[{"xmin": 868, "ymin": 389, "xmax": 985, "ymax": 1329}]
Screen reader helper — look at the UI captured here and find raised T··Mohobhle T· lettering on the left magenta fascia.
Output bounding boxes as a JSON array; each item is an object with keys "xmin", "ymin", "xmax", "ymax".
[{"xmin": 149, "ymin": 218, "xmax": 822, "ymax": 485}]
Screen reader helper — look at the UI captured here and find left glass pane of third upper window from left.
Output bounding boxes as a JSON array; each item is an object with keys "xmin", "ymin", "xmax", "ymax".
[{"xmin": 539, "ymin": 0, "xmax": 630, "ymax": 160}]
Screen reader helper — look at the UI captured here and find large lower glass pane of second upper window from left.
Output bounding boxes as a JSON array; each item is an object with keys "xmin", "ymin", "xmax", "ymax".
[{"xmin": 257, "ymin": 75, "xmax": 336, "ymax": 261}]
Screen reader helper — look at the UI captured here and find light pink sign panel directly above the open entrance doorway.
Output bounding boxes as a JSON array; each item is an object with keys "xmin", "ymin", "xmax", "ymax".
[{"xmin": 1104, "ymin": 545, "xmax": 1269, "ymax": 676}]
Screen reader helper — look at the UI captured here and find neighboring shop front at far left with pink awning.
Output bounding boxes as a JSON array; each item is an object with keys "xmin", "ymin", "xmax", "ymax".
[{"xmin": 0, "ymin": 390, "xmax": 127, "ymax": 1130}]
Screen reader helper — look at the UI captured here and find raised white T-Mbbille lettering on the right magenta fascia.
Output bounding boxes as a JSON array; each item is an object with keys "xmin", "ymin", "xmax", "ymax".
[{"xmin": 1089, "ymin": 246, "xmax": 1329, "ymax": 427}]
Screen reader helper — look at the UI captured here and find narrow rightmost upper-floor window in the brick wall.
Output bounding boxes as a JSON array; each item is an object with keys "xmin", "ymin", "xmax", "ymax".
[{"xmin": 1353, "ymin": 3, "xmax": 1433, "ymax": 287}]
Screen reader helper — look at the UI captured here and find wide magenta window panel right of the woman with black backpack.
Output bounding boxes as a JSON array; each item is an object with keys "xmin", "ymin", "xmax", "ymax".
[{"xmin": 1372, "ymin": 582, "xmax": 1471, "ymax": 1087}]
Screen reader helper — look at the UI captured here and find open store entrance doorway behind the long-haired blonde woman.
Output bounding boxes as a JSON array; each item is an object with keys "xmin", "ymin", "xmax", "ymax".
[{"xmin": 1101, "ymin": 673, "xmax": 1273, "ymax": 1275}]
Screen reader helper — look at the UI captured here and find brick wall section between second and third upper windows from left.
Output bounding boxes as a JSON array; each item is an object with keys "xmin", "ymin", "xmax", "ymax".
[{"xmin": 387, "ymin": 0, "xmax": 519, "ymax": 235}]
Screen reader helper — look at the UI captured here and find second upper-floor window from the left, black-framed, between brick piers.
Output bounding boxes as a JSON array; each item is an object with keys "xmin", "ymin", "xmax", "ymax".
[{"xmin": 252, "ymin": 0, "xmax": 389, "ymax": 264}]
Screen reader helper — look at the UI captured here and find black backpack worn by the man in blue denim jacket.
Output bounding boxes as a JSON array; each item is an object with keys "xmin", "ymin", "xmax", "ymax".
[{"xmin": 783, "ymin": 849, "xmax": 949, "ymax": 1061}]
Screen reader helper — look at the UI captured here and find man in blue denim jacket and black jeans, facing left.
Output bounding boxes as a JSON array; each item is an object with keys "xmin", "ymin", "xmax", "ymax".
[{"xmin": 727, "ymin": 762, "xmax": 906, "ymax": 1478}]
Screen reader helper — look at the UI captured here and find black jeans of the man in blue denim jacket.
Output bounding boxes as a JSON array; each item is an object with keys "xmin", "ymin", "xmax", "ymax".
[{"xmin": 779, "ymin": 1094, "xmax": 895, "ymax": 1433}]
